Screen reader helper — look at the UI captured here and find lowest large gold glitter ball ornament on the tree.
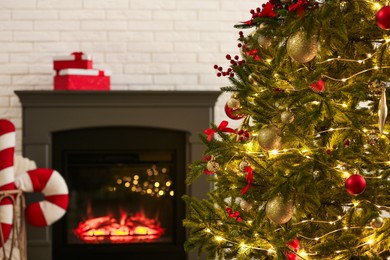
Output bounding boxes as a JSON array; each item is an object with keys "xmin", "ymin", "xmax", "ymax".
[{"xmin": 265, "ymin": 195, "xmax": 294, "ymax": 224}]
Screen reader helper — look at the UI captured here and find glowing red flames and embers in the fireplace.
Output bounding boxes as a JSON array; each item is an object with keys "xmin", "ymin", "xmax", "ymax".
[{"xmin": 73, "ymin": 210, "xmax": 164, "ymax": 243}]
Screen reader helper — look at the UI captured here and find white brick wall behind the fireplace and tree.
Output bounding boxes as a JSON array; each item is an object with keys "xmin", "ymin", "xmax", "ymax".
[{"xmin": 0, "ymin": 0, "xmax": 264, "ymax": 152}]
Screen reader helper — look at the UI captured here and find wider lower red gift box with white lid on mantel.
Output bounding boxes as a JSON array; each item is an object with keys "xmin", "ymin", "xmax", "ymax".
[{"xmin": 54, "ymin": 69, "xmax": 110, "ymax": 90}]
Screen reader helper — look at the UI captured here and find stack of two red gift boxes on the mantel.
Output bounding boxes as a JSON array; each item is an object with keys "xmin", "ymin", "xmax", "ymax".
[{"xmin": 53, "ymin": 52, "xmax": 110, "ymax": 90}]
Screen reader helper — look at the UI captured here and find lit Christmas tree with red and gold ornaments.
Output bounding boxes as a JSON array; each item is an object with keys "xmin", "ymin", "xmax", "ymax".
[{"xmin": 183, "ymin": 0, "xmax": 390, "ymax": 259}]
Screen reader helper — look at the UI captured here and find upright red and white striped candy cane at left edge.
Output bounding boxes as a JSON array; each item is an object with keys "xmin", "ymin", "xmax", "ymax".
[{"xmin": 0, "ymin": 119, "xmax": 15, "ymax": 247}]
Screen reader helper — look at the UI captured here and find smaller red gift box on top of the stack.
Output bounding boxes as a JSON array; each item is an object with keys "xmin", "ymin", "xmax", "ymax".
[{"xmin": 53, "ymin": 52, "xmax": 92, "ymax": 74}]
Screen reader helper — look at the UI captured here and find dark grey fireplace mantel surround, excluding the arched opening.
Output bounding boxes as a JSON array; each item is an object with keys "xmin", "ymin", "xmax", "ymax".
[{"xmin": 15, "ymin": 90, "xmax": 221, "ymax": 260}]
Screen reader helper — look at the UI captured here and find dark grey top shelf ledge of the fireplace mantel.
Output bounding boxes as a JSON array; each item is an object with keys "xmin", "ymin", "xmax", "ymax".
[{"xmin": 15, "ymin": 90, "xmax": 221, "ymax": 107}]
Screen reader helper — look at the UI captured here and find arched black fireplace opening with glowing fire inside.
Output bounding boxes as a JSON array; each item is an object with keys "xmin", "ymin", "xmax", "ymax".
[{"xmin": 52, "ymin": 127, "xmax": 188, "ymax": 260}]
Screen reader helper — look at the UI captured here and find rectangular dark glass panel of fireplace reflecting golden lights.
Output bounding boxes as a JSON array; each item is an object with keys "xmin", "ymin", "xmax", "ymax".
[{"xmin": 67, "ymin": 150, "xmax": 175, "ymax": 244}]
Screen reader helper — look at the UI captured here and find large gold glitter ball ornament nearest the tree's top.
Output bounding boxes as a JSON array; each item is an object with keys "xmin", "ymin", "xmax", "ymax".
[{"xmin": 286, "ymin": 31, "xmax": 318, "ymax": 63}]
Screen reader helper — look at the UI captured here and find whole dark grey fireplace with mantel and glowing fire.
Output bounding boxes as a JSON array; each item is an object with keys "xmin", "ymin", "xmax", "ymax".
[{"xmin": 16, "ymin": 91, "xmax": 219, "ymax": 260}]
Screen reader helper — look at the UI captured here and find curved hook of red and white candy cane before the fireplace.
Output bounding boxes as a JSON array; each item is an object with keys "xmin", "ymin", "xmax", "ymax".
[{"xmin": 15, "ymin": 168, "xmax": 69, "ymax": 227}]
